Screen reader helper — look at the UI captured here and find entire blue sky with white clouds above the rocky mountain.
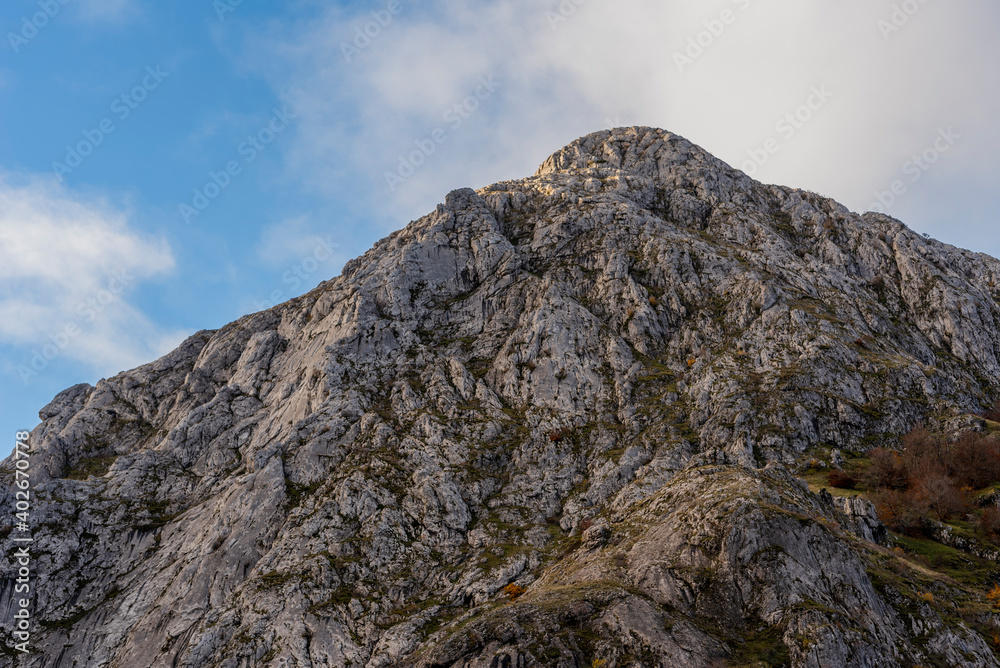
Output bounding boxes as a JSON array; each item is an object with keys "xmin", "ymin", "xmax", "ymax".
[{"xmin": 0, "ymin": 0, "xmax": 1000, "ymax": 444}]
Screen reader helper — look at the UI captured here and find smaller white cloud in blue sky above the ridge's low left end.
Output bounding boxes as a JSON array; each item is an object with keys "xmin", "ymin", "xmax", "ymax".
[{"xmin": 0, "ymin": 176, "xmax": 184, "ymax": 380}]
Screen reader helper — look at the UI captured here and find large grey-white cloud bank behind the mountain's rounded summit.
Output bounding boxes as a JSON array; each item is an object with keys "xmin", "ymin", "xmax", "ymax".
[{"xmin": 244, "ymin": 0, "xmax": 1000, "ymax": 252}]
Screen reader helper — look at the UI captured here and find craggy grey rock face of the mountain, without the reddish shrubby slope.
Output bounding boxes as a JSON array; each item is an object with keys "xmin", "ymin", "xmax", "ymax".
[{"xmin": 0, "ymin": 128, "xmax": 1000, "ymax": 668}]
